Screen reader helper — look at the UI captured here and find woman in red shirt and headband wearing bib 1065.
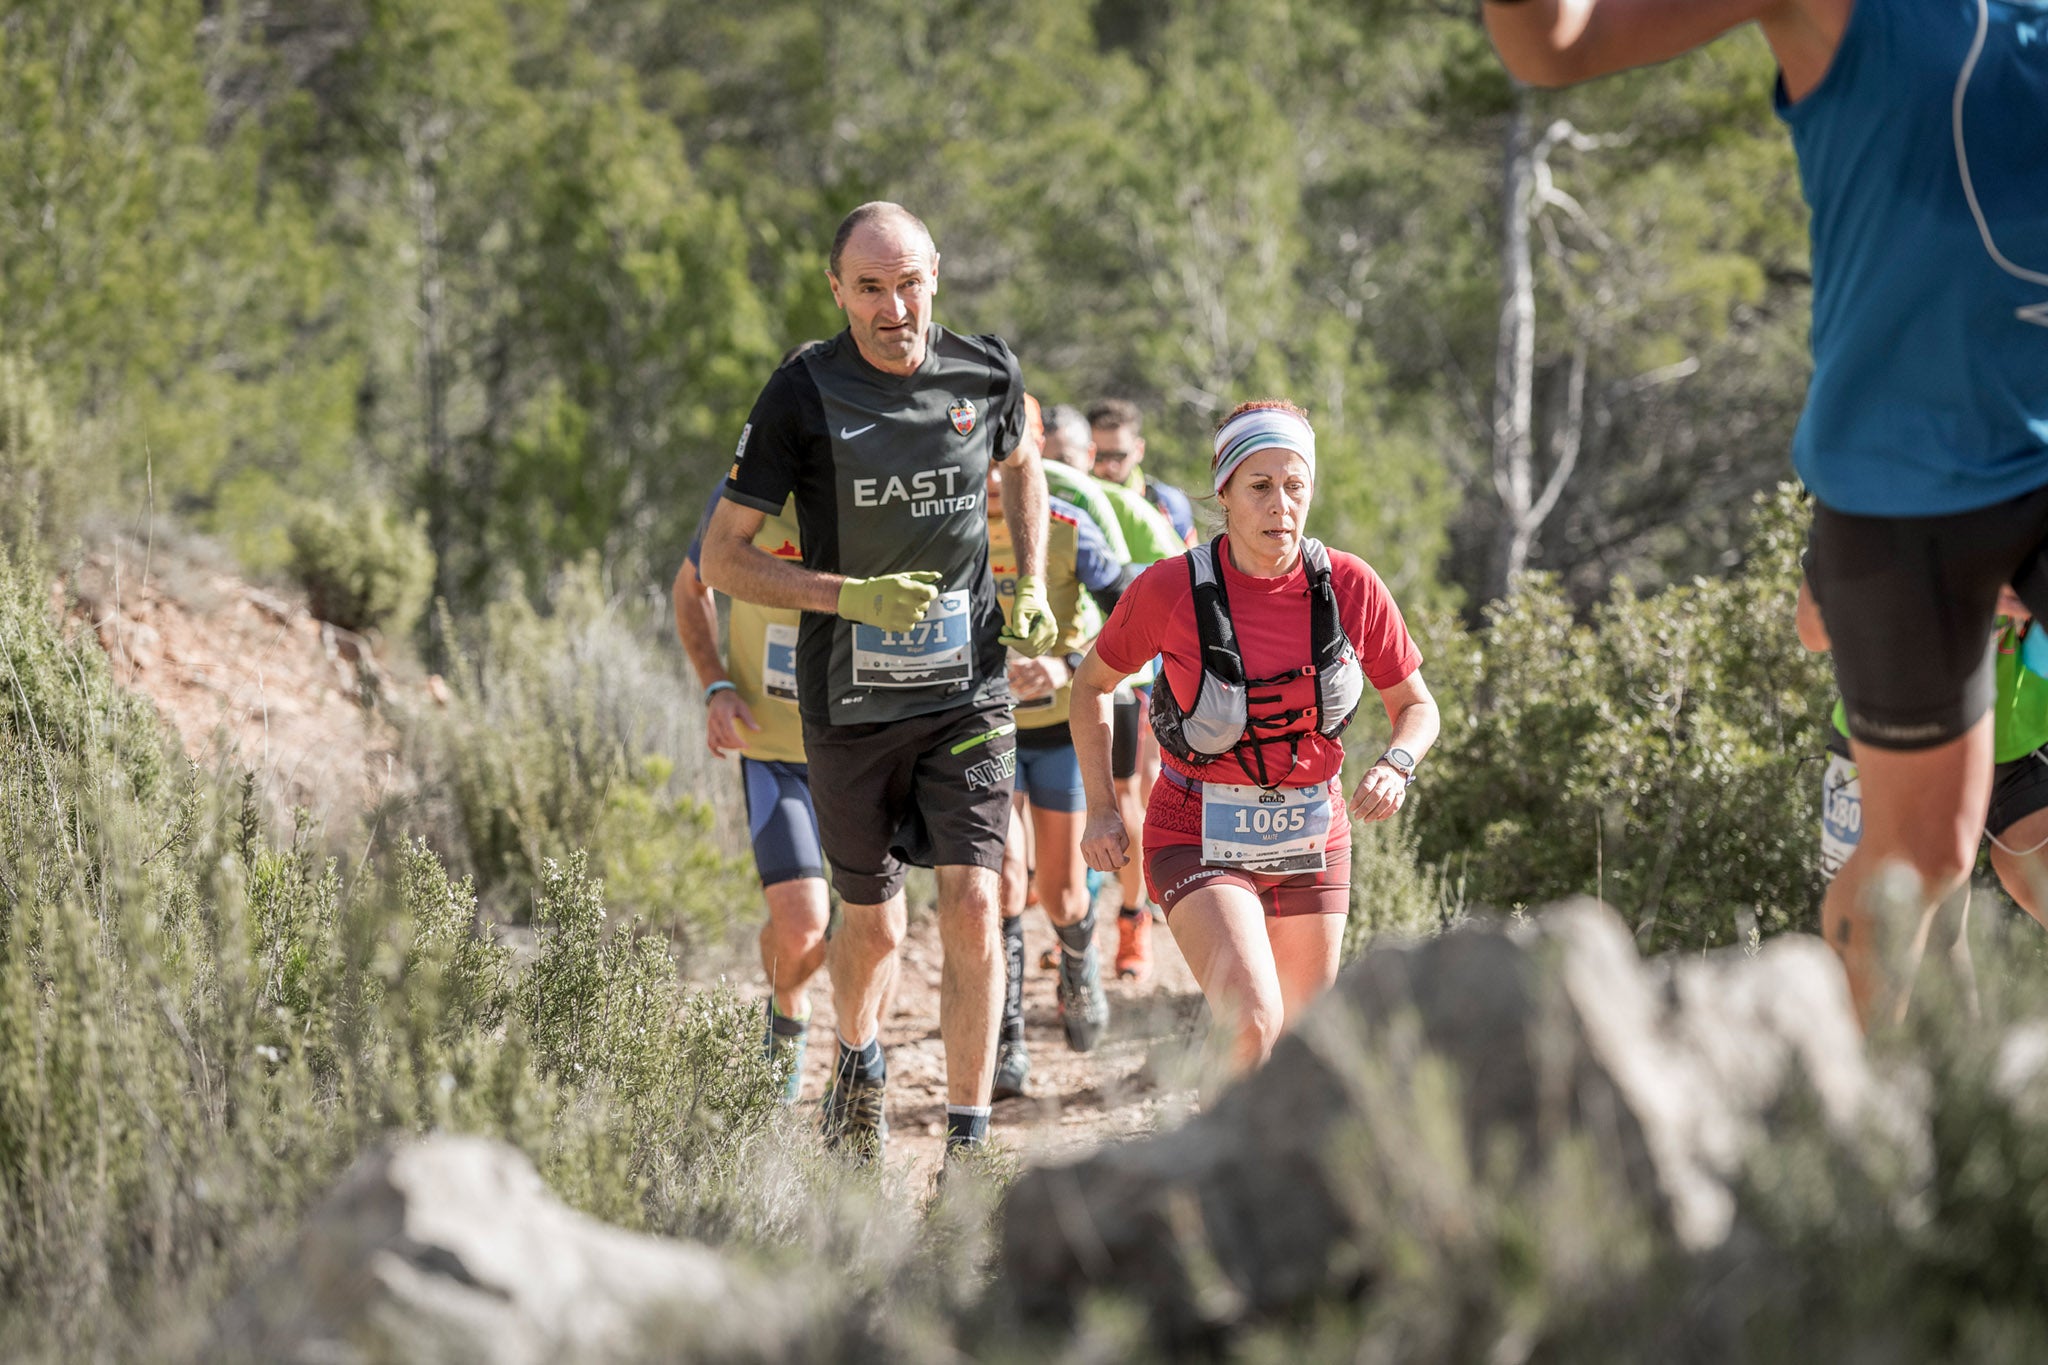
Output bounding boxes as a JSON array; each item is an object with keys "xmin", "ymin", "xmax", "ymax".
[{"xmin": 1071, "ymin": 399, "xmax": 1440, "ymax": 1070}]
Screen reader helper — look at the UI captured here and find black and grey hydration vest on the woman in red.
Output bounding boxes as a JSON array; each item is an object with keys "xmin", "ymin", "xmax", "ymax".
[{"xmin": 1151, "ymin": 536, "xmax": 1366, "ymax": 788}]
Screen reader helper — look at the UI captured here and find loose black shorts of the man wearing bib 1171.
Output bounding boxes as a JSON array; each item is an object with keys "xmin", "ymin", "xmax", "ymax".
[{"xmin": 803, "ymin": 704, "xmax": 1018, "ymax": 905}]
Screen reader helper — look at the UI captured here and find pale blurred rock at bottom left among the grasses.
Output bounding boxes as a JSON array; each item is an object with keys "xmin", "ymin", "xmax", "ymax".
[{"xmin": 213, "ymin": 1136, "xmax": 788, "ymax": 1365}]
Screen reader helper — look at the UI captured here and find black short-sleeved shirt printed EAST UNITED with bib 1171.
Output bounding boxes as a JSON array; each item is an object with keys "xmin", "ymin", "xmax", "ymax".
[{"xmin": 725, "ymin": 325, "xmax": 1024, "ymax": 724}]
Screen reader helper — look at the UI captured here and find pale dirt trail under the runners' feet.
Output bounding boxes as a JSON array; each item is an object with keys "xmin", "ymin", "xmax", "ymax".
[{"xmin": 803, "ymin": 890, "xmax": 1202, "ymax": 1179}]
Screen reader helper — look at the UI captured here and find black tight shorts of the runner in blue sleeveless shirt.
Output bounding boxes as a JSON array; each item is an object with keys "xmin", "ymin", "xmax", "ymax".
[{"xmin": 1806, "ymin": 487, "xmax": 2048, "ymax": 749}]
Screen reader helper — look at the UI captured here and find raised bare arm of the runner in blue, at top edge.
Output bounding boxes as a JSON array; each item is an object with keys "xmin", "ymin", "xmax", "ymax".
[{"xmin": 1481, "ymin": 0, "xmax": 1847, "ymax": 89}]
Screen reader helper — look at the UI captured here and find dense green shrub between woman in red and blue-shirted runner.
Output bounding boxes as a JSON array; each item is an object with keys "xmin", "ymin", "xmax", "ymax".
[{"xmin": 1413, "ymin": 489, "xmax": 1833, "ymax": 952}]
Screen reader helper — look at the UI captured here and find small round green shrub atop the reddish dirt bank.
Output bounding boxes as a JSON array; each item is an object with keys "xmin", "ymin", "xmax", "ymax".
[{"xmin": 287, "ymin": 501, "xmax": 434, "ymax": 634}]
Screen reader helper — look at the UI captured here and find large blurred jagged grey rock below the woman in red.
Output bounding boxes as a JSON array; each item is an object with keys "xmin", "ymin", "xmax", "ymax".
[{"xmin": 997, "ymin": 900, "xmax": 1913, "ymax": 1345}]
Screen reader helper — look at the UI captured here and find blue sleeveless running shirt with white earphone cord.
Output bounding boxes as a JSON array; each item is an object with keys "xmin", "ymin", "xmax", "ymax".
[{"xmin": 1776, "ymin": 0, "xmax": 2048, "ymax": 516}]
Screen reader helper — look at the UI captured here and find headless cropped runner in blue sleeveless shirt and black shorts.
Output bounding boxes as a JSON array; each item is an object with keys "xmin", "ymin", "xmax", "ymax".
[{"xmin": 1483, "ymin": 0, "xmax": 2048, "ymax": 1027}]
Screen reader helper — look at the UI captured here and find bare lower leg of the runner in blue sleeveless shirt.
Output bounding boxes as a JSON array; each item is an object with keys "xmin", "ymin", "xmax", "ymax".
[{"xmin": 1821, "ymin": 716, "xmax": 1991, "ymax": 1029}]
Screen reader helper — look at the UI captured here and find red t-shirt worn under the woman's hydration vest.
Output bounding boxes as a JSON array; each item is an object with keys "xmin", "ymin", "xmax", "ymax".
[{"xmin": 1096, "ymin": 551, "xmax": 1421, "ymax": 847}]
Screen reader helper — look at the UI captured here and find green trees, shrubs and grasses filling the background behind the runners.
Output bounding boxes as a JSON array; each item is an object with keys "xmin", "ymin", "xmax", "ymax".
[{"xmin": 0, "ymin": 0, "xmax": 2007, "ymax": 1359}]
